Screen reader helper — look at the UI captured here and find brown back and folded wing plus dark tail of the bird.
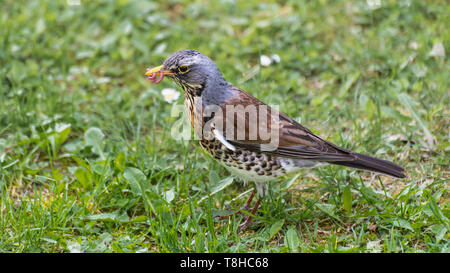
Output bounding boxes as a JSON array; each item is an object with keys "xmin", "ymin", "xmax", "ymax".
[{"xmin": 207, "ymin": 86, "xmax": 405, "ymax": 178}]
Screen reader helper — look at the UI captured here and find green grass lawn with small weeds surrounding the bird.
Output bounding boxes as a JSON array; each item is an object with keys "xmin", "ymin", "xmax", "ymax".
[{"xmin": 0, "ymin": 0, "xmax": 450, "ymax": 252}]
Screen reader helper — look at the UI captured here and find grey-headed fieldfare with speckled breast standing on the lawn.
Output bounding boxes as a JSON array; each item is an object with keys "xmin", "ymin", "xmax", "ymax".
[{"xmin": 145, "ymin": 50, "xmax": 405, "ymax": 229}]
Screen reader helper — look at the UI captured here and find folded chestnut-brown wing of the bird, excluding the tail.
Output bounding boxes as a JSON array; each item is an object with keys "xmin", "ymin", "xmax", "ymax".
[{"xmin": 218, "ymin": 86, "xmax": 354, "ymax": 162}]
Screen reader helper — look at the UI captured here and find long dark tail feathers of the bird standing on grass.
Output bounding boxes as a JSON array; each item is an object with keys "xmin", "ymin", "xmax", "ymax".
[{"xmin": 330, "ymin": 153, "xmax": 405, "ymax": 178}]
